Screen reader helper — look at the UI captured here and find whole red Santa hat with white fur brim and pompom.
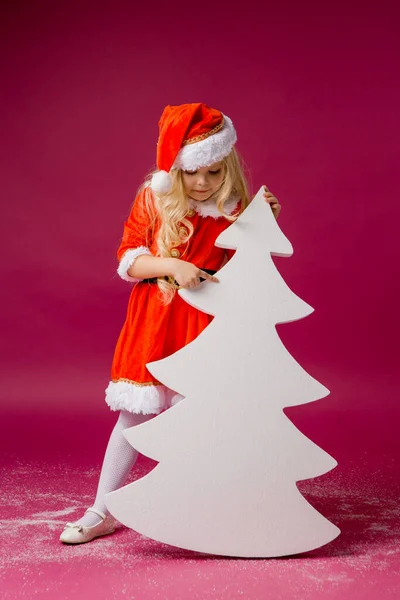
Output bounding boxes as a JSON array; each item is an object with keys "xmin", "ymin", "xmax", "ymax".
[{"xmin": 150, "ymin": 102, "xmax": 237, "ymax": 193}]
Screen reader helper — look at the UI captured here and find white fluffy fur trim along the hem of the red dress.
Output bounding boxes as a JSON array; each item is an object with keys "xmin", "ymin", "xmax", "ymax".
[{"xmin": 106, "ymin": 381, "xmax": 183, "ymax": 415}]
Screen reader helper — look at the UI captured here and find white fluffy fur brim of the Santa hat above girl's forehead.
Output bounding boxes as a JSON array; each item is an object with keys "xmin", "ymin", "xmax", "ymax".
[{"xmin": 172, "ymin": 115, "xmax": 237, "ymax": 171}]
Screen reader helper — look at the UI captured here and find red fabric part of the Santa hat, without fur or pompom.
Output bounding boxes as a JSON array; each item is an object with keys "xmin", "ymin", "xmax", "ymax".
[{"xmin": 157, "ymin": 102, "xmax": 223, "ymax": 172}]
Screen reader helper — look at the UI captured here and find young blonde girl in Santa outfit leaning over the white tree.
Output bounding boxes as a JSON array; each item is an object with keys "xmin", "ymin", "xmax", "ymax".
[{"xmin": 60, "ymin": 103, "xmax": 280, "ymax": 544}]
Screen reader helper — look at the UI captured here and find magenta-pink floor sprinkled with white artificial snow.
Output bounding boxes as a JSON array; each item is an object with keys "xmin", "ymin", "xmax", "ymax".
[{"xmin": 0, "ymin": 404, "xmax": 400, "ymax": 600}]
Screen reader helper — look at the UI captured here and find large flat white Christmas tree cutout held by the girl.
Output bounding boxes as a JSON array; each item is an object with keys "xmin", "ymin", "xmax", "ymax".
[{"xmin": 106, "ymin": 189, "xmax": 340, "ymax": 557}]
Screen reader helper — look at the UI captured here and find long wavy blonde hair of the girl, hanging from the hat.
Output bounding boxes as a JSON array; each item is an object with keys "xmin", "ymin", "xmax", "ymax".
[{"xmin": 140, "ymin": 147, "xmax": 250, "ymax": 304}]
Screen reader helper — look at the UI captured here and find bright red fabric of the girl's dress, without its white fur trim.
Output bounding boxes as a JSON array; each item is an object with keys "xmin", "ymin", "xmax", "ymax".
[{"xmin": 111, "ymin": 192, "xmax": 239, "ymax": 383}]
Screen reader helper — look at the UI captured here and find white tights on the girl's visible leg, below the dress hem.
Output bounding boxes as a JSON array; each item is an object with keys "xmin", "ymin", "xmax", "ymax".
[{"xmin": 76, "ymin": 410, "xmax": 155, "ymax": 527}]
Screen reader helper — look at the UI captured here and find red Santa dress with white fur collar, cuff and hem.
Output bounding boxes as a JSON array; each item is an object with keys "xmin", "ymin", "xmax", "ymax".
[{"xmin": 106, "ymin": 190, "xmax": 240, "ymax": 414}]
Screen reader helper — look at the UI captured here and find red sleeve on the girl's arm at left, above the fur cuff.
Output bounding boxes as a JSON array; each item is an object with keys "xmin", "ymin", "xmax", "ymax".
[{"xmin": 117, "ymin": 188, "xmax": 156, "ymax": 261}]
